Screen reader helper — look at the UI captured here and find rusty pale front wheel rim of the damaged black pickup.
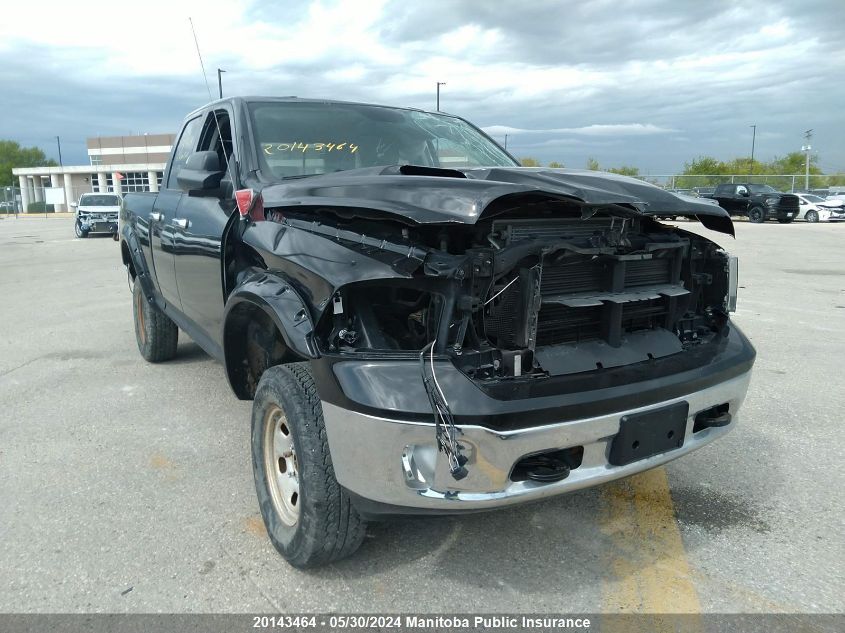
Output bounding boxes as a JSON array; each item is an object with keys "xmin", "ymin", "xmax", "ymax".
[{"xmin": 264, "ymin": 405, "xmax": 301, "ymax": 527}]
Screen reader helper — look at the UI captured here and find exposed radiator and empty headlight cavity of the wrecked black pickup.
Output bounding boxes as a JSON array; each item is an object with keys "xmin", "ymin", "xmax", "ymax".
[{"xmin": 312, "ymin": 203, "xmax": 735, "ymax": 385}]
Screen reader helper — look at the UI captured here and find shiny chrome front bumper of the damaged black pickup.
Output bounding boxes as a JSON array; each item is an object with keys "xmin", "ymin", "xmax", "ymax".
[{"xmin": 323, "ymin": 371, "xmax": 751, "ymax": 513}]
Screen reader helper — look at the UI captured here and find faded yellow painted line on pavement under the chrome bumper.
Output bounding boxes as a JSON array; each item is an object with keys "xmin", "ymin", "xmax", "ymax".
[{"xmin": 601, "ymin": 468, "xmax": 702, "ymax": 631}]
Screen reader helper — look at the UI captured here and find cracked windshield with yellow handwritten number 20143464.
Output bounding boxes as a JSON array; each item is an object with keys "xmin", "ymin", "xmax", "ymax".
[{"xmin": 249, "ymin": 103, "xmax": 517, "ymax": 178}]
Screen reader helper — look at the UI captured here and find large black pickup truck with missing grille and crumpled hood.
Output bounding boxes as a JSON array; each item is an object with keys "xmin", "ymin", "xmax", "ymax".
[{"xmin": 120, "ymin": 97, "xmax": 755, "ymax": 567}]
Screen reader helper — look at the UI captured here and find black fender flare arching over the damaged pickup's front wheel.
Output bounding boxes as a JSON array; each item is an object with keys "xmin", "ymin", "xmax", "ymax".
[{"xmin": 223, "ymin": 271, "xmax": 320, "ymax": 366}]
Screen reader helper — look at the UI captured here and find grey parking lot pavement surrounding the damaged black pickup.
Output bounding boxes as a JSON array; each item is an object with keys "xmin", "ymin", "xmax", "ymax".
[{"xmin": 0, "ymin": 217, "xmax": 845, "ymax": 613}]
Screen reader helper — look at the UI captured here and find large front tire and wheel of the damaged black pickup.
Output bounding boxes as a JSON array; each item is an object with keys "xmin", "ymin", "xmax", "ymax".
[{"xmin": 252, "ymin": 363, "xmax": 366, "ymax": 568}]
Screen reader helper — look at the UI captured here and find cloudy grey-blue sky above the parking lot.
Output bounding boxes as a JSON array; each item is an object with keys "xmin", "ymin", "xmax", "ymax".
[{"xmin": 0, "ymin": 0, "xmax": 845, "ymax": 174}]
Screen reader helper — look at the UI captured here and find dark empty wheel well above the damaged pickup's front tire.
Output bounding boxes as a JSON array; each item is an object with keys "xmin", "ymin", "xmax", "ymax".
[{"xmin": 223, "ymin": 302, "xmax": 302, "ymax": 400}]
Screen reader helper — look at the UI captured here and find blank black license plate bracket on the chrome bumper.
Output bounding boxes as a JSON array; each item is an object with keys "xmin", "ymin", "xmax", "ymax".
[{"xmin": 608, "ymin": 402, "xmax": 689, "ymax": 466}]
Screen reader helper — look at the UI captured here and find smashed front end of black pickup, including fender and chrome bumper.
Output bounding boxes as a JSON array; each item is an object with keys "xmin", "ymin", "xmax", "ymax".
[{"xmin": 234, "ymin": 189, "xmax": 753, "ymax": 510}]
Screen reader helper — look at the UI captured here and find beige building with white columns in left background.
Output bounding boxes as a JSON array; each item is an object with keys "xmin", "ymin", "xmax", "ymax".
[{"xmin": 12, "ymin": 134, "xmax": 175, "ymax": 212}]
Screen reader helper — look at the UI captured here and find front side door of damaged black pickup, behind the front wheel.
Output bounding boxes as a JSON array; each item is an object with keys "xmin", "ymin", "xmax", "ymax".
[{"xmin": 169, "ymin": 106, "xmax": 237, "ymax": 348}]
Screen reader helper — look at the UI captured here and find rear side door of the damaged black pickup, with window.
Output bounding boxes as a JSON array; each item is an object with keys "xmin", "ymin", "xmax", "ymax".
[{"xmin": 149, "ymin": 117, "xmax": 202, "ymax": 310}]
